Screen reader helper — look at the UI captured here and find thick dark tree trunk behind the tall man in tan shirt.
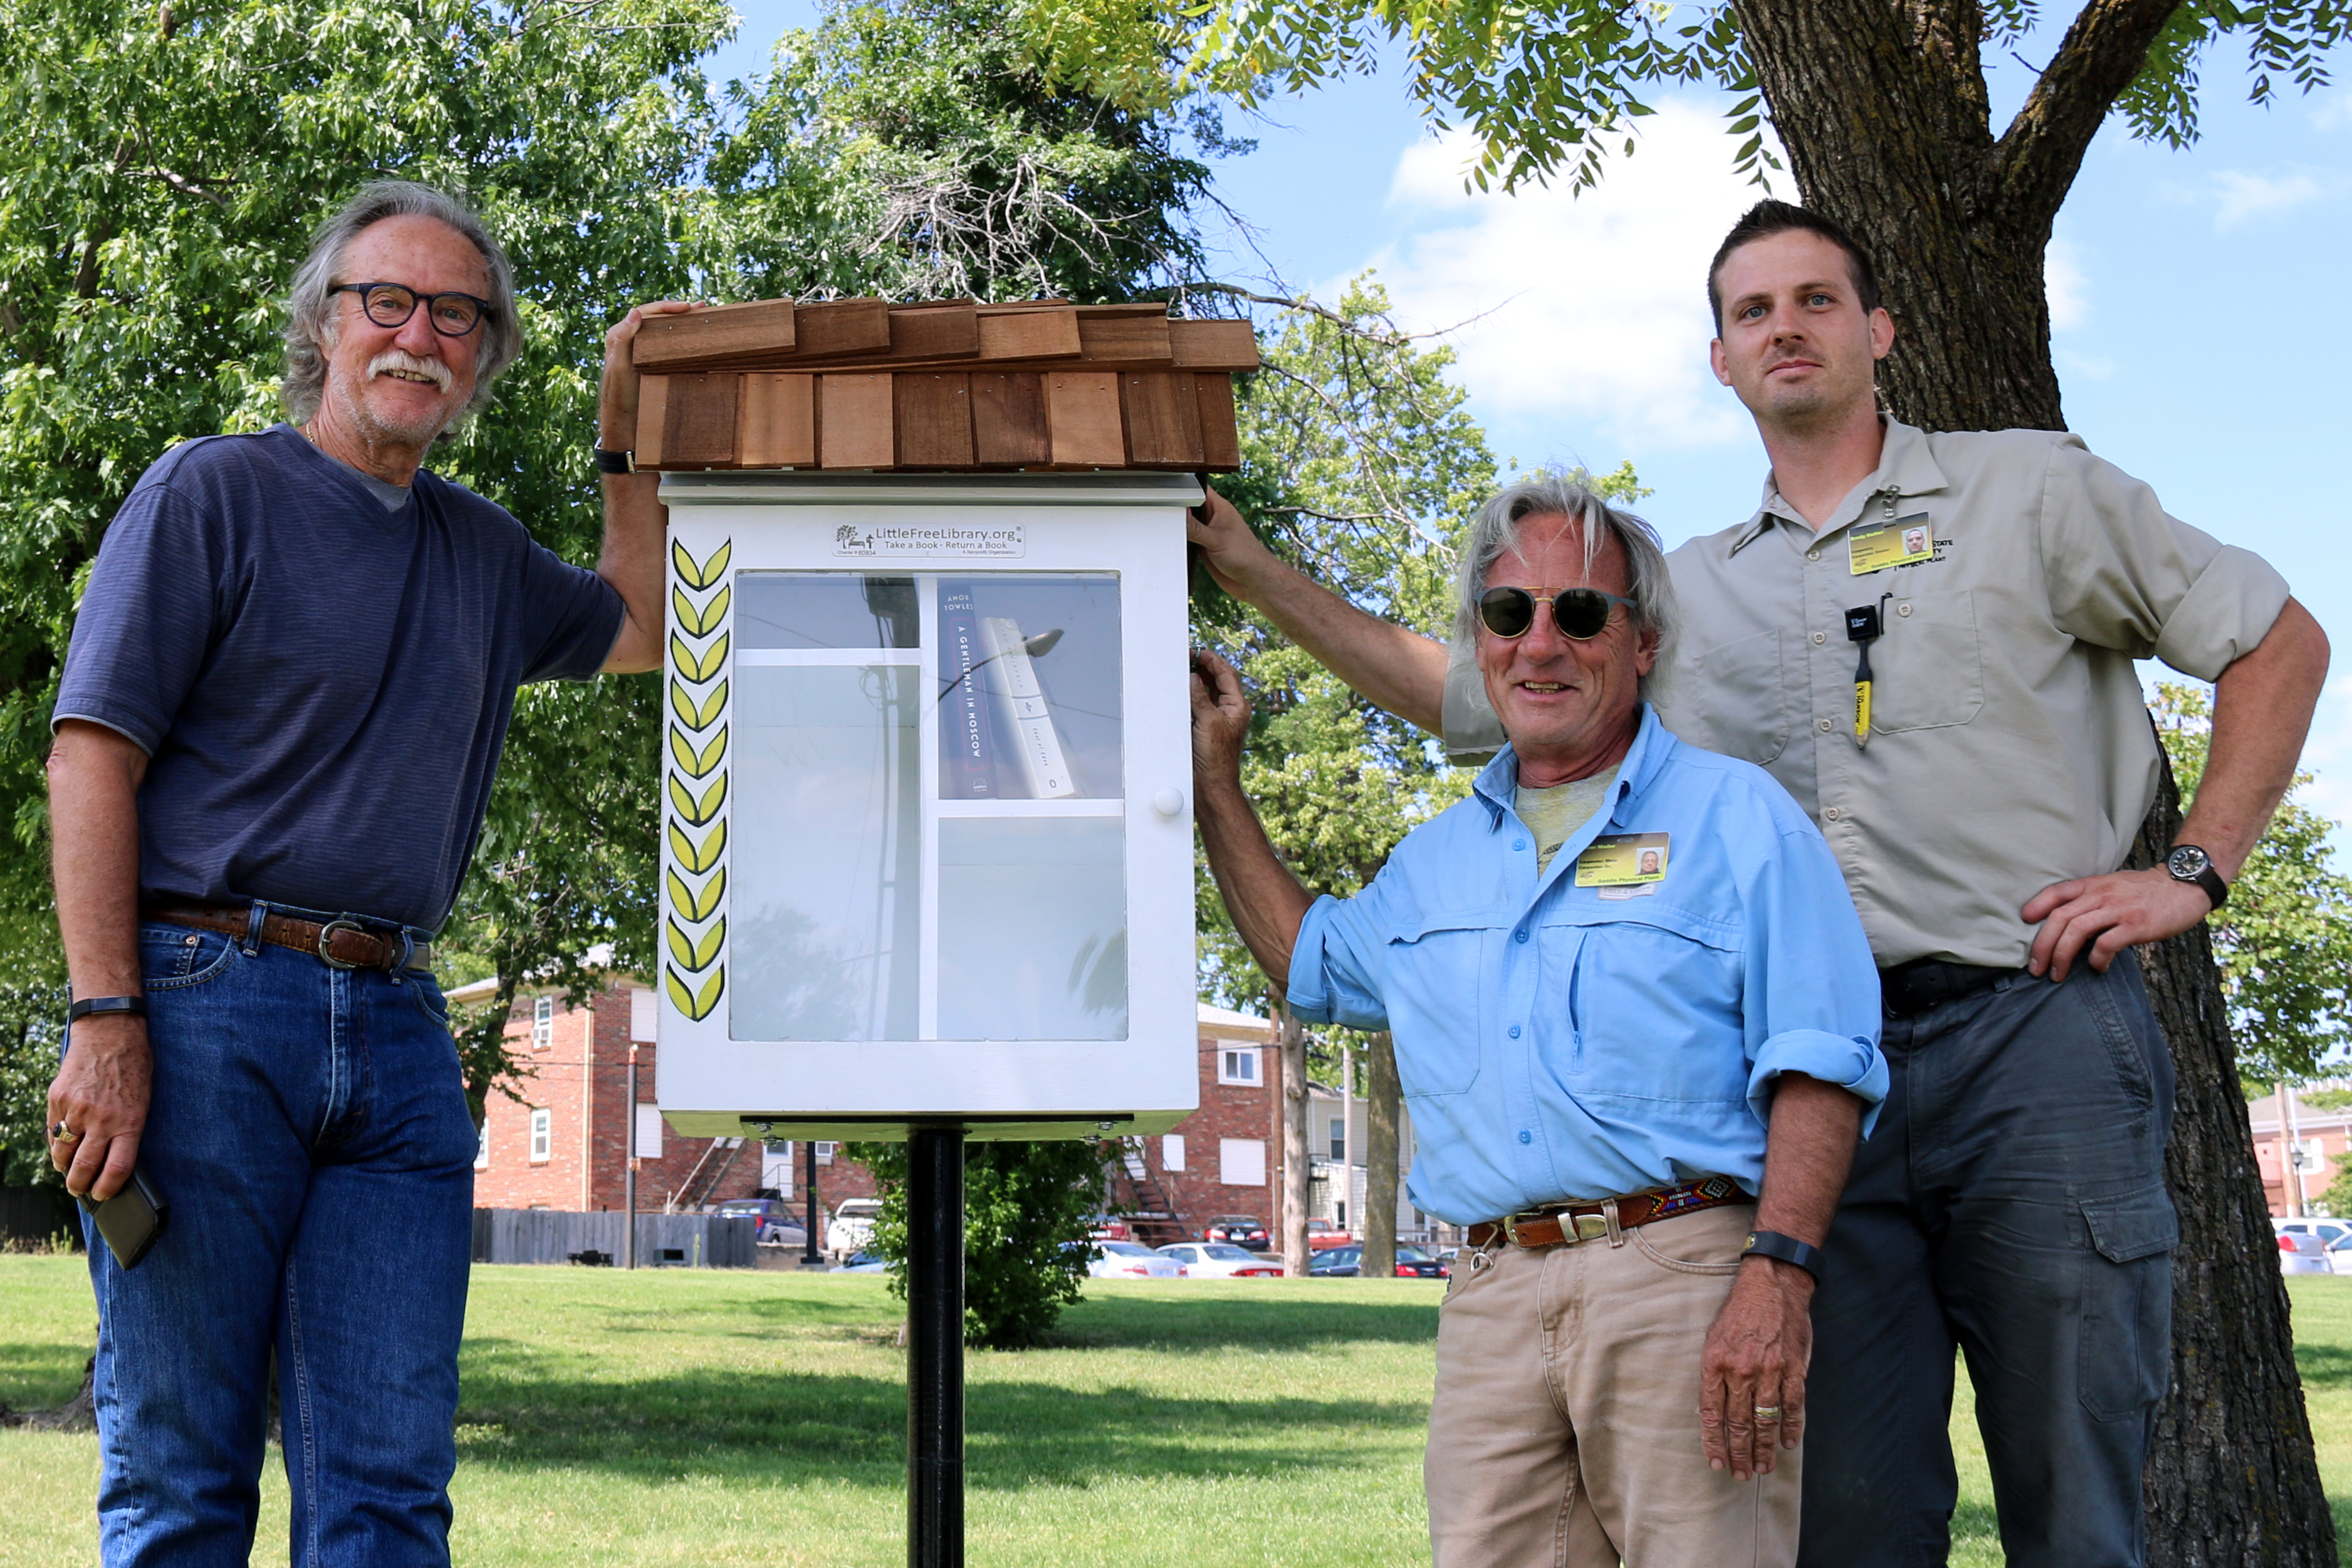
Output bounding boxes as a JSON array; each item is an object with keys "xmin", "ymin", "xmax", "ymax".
[{"xmin": 1733, "ymin": 0, "xmax": 2336, "ymax": 1568}]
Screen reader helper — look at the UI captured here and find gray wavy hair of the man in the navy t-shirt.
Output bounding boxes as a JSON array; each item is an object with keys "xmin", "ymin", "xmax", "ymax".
[{"xmin": 278, "ymin": 179, "xmax": 522, "ymax": 426}]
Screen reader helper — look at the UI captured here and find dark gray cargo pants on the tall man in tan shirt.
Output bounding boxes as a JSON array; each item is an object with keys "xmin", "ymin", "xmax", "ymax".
[{"xmin": 1797, "ymin": 952, "xmax": 2180, "ymax": 1568}]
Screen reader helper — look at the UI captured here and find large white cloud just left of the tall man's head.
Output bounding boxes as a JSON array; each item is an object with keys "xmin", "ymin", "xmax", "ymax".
[{"xmin": 1371, "ymin": 99, "xmax": 1762, "ymax": 458}]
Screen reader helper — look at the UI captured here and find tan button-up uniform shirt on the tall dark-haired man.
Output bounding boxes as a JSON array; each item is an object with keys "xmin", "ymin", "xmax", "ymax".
[{"xmin": 1444, "ymin": 421, "xmax": 2286, "ymax": 968}]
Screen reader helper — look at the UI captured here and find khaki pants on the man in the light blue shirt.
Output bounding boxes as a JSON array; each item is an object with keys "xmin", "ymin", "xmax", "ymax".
[{"xmin": 1423, "ymin": 1204, "xmax": 1799, "ymax": 1568}]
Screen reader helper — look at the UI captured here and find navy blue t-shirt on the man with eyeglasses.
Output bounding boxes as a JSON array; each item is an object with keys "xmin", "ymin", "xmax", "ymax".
[{"xmin": 52, "ymin": 426, "xmax": 624, "ymax": 931}]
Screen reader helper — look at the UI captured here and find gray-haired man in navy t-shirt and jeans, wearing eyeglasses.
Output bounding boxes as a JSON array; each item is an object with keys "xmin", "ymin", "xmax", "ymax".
[{"xmin": 50, "ymin": 181, "xmax": 684, "ymax": 1565}]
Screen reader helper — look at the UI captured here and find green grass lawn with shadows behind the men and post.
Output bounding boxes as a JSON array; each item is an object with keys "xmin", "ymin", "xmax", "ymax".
[{"xmin": 0, "ymin": 1258, "xmax": 2352, "ymax": 1568}]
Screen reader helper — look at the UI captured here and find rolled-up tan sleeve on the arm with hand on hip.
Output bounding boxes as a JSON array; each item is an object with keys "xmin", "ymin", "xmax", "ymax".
[{"xmin": 2042, "ymin": 439, "xmax": 2289, "ymax": 679}]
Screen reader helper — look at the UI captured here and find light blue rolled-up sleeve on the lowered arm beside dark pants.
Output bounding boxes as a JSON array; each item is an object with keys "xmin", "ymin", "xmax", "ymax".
[{"xmin": 1745, "ymin": 823, "xmax": 1886, "ymax": 1138}]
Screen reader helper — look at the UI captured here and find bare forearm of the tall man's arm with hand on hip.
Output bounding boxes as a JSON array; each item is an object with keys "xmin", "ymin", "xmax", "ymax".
[{"xmin": 2180, "ymin": 600, "xmax": 2328, "ymax": 877}]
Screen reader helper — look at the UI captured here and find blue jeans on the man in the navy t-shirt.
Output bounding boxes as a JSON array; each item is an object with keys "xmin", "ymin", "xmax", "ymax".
[{"xmin": 90, "ymin": 924, "xmax": 478, "ymax": 1568}]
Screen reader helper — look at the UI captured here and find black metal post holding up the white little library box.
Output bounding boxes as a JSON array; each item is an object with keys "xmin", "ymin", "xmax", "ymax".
[{"xmin": 906, "ymin": 1126, "xmax": 964, "ymax": 1568}]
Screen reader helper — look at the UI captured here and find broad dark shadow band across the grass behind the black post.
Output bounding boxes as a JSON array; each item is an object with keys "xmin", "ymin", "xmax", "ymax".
[{"xmin": 459, "ymin": 1340, "xmax": 1428, "ymax": 1490}]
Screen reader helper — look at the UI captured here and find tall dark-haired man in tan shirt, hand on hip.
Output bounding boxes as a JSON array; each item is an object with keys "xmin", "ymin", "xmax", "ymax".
[{"xmin": 1193, "ymin": 202, "xmax": 2326, "ymax": 1568}]
